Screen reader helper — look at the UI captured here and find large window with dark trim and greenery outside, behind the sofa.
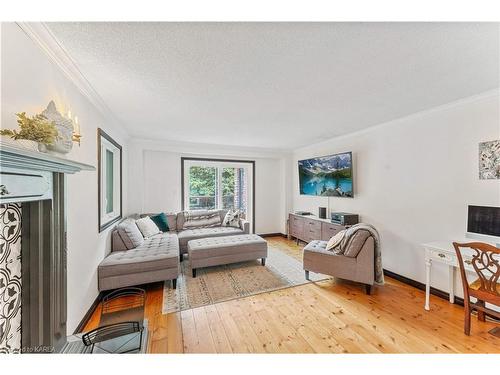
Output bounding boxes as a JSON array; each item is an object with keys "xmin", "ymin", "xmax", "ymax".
[{"xmin": 182, "ymin": 158, "xmax": 255, "ymax": 232}]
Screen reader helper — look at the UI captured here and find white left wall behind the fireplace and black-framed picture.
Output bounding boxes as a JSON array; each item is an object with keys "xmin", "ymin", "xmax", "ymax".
[{"xmin": 1, "ymin": 23, "xmax": 127, "ymax": 333}]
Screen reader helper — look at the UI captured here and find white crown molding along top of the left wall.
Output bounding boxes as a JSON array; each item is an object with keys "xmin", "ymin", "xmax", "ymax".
[{"xmin": 16, "ymin": 22, "xmax": 126, "ymax": 137}]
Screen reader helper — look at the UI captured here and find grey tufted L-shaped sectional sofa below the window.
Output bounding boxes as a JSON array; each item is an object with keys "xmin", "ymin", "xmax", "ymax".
[{"xmin": 97, "ymin": 210, "xmax": 250, "ymax": 291}]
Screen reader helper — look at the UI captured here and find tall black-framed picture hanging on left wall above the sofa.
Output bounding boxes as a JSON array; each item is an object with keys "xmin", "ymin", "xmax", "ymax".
[{"xmin": 97, "ymin": 128, "xmax": 122, "ymax": 232}]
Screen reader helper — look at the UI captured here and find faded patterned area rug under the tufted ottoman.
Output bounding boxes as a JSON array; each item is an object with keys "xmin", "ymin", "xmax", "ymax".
[{"xmin": 163, "ymin": 245, "xmax": 328, "ymax": 314}]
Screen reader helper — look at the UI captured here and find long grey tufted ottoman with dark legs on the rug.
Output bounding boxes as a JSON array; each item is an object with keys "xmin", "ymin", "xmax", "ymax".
[{"xmin": 188, "ymin": 234, "xmax": 267, "ymax": 277}]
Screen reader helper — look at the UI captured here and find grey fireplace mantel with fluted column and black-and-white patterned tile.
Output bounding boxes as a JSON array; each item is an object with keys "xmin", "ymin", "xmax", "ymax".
[{"xmin": 0, "ymin": 142, "xmax": 97, "ymax": 353}]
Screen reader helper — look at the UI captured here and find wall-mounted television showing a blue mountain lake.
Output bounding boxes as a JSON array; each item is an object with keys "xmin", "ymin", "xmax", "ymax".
[{"xmin": 298, "ymin": 152, "xmax": 354, "ymax": 198}]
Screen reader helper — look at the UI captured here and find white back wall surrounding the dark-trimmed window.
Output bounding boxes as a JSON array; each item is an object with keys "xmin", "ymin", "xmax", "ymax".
[{"xmin": 129, "ymin": 140, "xmax": 286, "ymax": 234}]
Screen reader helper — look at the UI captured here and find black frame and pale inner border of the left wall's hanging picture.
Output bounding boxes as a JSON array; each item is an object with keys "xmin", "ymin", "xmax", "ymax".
[{"xmin": 97, "ymin": 128, "xmax": 123, "ymax": 233}]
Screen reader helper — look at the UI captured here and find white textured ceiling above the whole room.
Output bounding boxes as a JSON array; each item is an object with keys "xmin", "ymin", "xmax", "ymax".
[{"xmin": 48, "ymin": 23, "xmax": 499, "ymax": 149}]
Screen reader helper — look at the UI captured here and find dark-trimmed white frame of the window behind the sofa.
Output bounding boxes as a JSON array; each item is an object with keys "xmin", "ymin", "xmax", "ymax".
[{"xmin": 181, "ymin": 157, "xmax": 255, "ymax": 233}]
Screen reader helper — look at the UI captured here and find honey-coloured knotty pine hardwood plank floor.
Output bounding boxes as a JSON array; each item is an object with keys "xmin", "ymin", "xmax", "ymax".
[{"xmin": 80, "ymin": 237, "xmax": 500, "ymax": 353}]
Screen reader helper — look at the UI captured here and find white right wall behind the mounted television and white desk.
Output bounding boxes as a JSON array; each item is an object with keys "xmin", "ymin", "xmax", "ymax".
[{"xmin": 291, "ymin": 91, "xmax": 500, "ymax": 296}]
